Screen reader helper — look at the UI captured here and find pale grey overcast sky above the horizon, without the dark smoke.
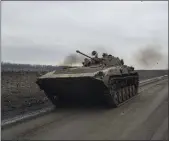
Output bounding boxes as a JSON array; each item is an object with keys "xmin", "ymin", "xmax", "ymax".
[{"xmin": 1, "ymin": 1, "xmax": 168, "ymax": 67}]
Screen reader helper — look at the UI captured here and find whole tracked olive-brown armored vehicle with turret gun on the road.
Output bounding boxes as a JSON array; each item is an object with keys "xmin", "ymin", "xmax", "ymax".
[{"xmin": 36, "ymin": 50, "xmax": 139, "ymax": 107}]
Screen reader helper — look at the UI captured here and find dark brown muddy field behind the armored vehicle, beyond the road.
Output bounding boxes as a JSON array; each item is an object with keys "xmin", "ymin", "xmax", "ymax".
[{"xmin": 1, "ymin": 70, "xmax": 168, "ymax": 120}]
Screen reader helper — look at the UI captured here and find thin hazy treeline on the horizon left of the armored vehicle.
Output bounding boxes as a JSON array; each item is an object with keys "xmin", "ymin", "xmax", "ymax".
[{"xmin": 1, "ymin": 62, "xmax": 66, "ymax": 72}]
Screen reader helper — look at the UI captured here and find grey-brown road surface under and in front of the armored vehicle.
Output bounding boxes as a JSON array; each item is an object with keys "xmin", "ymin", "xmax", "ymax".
[{"xmin": 1, "ymin": 80, "xmax": 168, "ymax": 140}]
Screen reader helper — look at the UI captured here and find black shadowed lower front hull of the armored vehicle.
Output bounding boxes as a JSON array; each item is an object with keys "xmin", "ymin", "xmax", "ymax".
[{"xmin": 37, "ymin": 77, "xmax": 108, "ymax": 100}]
